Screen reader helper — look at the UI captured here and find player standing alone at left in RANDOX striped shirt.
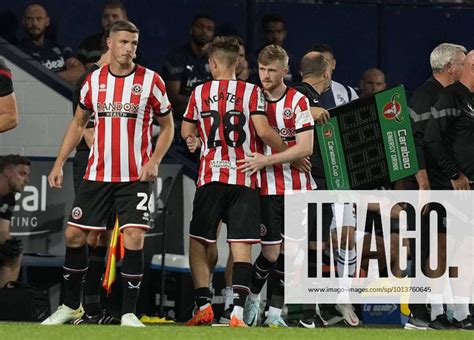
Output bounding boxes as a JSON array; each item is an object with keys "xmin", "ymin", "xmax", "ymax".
[{"xmin": 43, "ymin": 21, "xmax": 174, "ymax": 327}]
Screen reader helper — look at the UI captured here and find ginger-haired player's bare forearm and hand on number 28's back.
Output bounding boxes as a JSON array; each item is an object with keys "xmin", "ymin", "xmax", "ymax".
[{"xmin": 239, "ymin": 127, "xmax": 314, "ymax": 174}]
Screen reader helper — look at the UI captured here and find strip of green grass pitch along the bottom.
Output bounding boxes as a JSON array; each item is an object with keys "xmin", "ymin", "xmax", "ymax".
[{"xmin": 0, "ymin": 323, "xmax": 466, "ymax": 340}]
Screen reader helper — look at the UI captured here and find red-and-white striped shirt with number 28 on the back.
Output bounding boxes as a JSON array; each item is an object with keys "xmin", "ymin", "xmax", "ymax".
[{"xmin": 183, "ymin": 80, "xmax": 265, "ymax": 188}]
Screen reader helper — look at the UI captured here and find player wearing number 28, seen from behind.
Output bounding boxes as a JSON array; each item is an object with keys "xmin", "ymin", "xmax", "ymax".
[{"xmin": 181, "ymin": 37, "xmax": 312, "ymax": 327}]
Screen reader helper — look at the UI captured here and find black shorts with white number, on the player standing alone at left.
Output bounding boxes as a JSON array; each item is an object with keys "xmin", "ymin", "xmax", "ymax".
[{"xmin": 68, "ymin": 180, "xmax": 151, "ymax": 230}]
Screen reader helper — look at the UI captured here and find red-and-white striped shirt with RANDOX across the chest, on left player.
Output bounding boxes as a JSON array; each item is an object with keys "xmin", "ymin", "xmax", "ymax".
[{"xmin": 80, "ymin": 65, "xmax": 171, "ymax": 182}]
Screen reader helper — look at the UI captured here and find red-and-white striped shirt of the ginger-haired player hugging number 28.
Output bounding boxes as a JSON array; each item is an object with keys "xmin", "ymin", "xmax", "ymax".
[{"xmin": 260, "ymin": 88, "xmax": 316, "ymax": 196}]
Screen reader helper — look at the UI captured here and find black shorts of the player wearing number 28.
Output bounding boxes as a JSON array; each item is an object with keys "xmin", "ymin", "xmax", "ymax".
[{"xmin": 189, "ymin": 182, "xmax": 260, "ymax": 243}]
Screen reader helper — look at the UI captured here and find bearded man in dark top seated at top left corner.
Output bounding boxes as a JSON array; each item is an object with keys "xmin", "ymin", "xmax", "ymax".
[{"xmin": 20, "ymin": 4, "xmax": 84, "ymax": 83}]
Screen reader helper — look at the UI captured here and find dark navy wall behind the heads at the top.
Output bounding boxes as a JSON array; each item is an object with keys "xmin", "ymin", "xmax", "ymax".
[{"xmin": 0, "ymin": 0, "xmax": 474, "ymax": 93}]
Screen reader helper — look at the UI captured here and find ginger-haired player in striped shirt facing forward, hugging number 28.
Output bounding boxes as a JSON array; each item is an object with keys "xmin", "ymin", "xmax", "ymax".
[{"xmin": 239, "ymin": 45, "xmax": 316, "ymax": 327}]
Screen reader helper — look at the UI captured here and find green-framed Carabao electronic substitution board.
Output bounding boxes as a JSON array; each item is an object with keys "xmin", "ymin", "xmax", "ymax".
[{"xmin": 316, "ymin": 86, "xmax": 418, "ymax": 190}]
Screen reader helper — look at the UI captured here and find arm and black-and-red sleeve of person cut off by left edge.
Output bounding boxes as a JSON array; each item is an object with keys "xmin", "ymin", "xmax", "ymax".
[{"xmin": 0, "ymin": 59, "xmax": 18, "ymax": 133}]
